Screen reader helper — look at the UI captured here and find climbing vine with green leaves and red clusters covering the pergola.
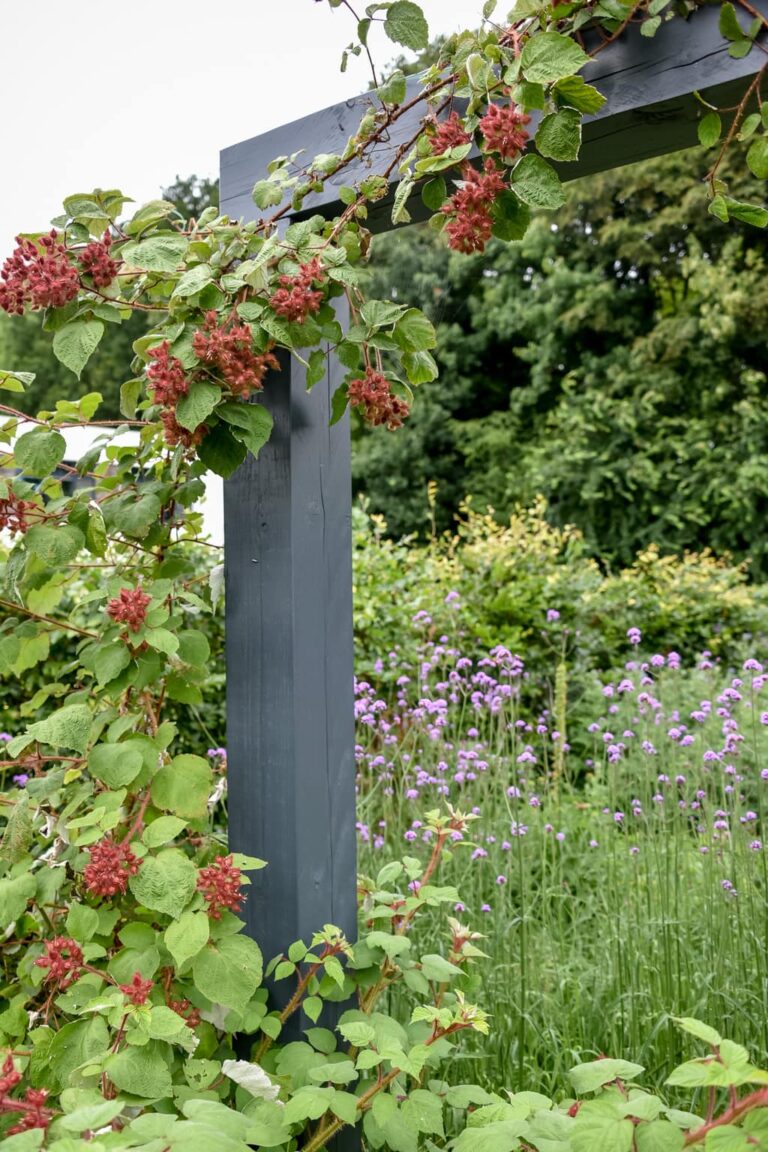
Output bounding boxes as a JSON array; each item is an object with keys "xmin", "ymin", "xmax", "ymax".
[{"xmin": 0, "ymin": 0, "xmax": 768, "ymax": 1152}]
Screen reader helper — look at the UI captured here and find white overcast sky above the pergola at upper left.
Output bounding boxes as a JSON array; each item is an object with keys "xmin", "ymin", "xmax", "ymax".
[{"xmin": 0, "ymin": 0, "xmax": 481, "ymax": 253}]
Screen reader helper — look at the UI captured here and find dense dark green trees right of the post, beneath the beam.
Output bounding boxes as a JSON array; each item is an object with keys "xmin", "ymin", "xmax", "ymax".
[{"xmin": 355, "ymin": 144, "xmax": 768, "ymax": 577}]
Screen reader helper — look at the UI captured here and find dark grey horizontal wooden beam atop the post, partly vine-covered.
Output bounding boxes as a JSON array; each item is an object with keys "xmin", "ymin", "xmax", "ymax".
[{"xmin": 221, "ymin": 0, "xmax": 768, "ymax": 232}]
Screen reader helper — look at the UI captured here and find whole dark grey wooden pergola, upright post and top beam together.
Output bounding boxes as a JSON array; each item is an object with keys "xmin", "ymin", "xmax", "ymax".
[{"xmin": 221, "ymin": 9, "xmax": 768, "ymax": 990}]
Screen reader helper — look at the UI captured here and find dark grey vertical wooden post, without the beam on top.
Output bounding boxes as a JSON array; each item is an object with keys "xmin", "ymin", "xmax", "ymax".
[{"xmin": 225, "ymin": 324, "xmax": 356, "ymax": 1018}]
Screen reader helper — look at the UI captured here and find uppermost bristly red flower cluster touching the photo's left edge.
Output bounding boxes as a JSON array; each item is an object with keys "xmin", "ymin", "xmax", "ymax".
[{"xmin": 0, "ymin": 228, "xmax": 79, "ymax": 316}]
